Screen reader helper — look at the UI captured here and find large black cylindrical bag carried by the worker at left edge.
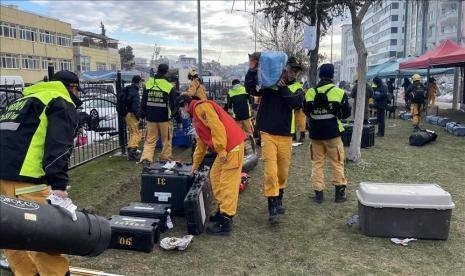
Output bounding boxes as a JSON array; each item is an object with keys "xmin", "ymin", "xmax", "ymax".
[{"xmin": 0, "ymin": 195, "xmax": 111, "ymax": 256}]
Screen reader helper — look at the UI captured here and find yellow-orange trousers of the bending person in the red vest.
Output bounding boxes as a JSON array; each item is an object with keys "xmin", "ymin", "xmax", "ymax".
[{"xmin": 210, "ymin": 143, "xmax": 244, "ymax": 216}]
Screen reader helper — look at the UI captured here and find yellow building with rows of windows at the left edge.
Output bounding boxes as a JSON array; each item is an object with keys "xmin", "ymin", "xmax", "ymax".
[{"xmin": 0, "ymin": 5, "xmax": 73, "ymax": 83}]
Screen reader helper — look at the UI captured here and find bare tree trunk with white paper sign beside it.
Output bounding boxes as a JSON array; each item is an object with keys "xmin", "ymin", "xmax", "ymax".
[{"xmin": 347, "ymin": 11, "xmax": 368, "ymax": 162}]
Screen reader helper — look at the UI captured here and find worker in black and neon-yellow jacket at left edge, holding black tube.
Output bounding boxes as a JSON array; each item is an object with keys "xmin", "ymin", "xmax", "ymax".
[{"xmin": 0, "ymin": 70, "xmax": 82, "ymax": 276}]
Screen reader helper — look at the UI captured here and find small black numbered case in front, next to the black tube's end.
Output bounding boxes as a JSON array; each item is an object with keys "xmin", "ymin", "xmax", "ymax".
[{"xmin": 109, "ymin": 216, "xmax": 160, "ymax": 252}]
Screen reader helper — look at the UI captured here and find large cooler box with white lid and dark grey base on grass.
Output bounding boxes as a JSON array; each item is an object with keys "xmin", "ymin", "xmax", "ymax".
[{"xmin": 357, "ymin": 182, "xmax": 455, "ymax": 240}]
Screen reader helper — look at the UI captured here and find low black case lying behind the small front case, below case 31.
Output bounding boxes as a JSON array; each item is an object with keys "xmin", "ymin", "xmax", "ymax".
[{"xmin": 119, "ymin": 202, "xmax": 171, "ymax": 233}]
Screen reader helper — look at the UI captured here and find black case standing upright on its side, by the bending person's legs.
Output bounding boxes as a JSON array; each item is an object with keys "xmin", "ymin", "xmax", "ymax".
[{"xmin": 184, "ymin": 169, "xmax": 212, "ymax": 235}]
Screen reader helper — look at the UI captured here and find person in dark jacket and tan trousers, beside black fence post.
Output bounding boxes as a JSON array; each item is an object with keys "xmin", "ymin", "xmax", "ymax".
[{"xmin": 123, "ymin": 76, "xmax": 142, "ymax": 161}]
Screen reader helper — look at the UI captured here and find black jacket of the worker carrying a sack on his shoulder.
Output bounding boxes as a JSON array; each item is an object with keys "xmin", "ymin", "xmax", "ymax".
[{"xmin": 244, "ymin": 70, "xmax": 303, "ymax": 136}]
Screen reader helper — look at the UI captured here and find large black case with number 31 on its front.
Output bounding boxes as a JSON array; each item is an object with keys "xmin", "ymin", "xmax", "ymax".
[{"xmin": 140, "ymin": 162, "xmax": 193, "ymax": 216}]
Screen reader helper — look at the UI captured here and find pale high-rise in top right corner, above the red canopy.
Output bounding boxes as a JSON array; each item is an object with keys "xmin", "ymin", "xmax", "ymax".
[{"xmin": 405, "ymin": 0, "xmax": 465, "ymax": 57}]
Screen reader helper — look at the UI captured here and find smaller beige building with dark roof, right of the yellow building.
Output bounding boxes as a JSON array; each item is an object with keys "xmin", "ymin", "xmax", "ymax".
[{"xmin": 73, "ymin": 29, "xmax": 121, "ymax": 74}]
